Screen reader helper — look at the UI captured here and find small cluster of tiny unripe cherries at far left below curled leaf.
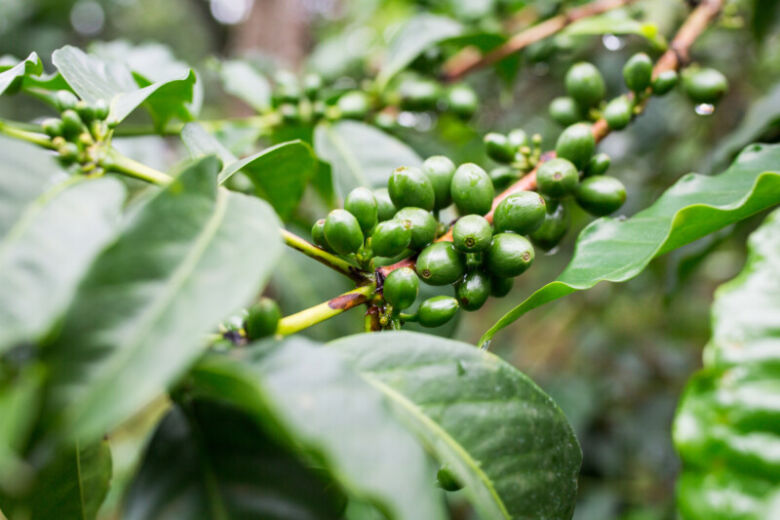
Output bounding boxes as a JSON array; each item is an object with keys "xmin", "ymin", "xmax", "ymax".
[{"xmin": 41, "ymin": 90, "xmax": 108, "ymax": 174}]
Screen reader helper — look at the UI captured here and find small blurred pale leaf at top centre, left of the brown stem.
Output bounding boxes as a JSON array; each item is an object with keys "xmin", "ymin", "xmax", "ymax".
[{"xmin": 377, "ymin": 14, "xmax": 463, "ymax": 88}]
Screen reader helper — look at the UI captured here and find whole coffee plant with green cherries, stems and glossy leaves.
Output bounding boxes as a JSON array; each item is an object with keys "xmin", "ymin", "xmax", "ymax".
[{"xmin": 0, "ymin": 0, "xmax": 780, "ymax": 520}]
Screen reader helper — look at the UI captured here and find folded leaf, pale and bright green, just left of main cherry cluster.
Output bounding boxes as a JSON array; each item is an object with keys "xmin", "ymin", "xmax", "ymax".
[{"xmin": 182, "ymin": 124, "xmax": 318, "ymax": 219}]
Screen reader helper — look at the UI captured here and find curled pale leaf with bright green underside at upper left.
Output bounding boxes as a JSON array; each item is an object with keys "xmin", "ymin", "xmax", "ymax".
[{"xmin": 52, "ymin": 45, "xmax": 196, "ymax": 126}]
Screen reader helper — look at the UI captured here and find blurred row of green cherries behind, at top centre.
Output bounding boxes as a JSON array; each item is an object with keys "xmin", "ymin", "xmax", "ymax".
[{"xmin": 272, "ymin": 71, "xmax": 478, "ymax": 129}]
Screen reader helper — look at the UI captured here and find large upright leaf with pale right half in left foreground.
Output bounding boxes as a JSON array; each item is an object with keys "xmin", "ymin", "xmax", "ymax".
[{"xmin": 45, "ymin": 157, "xmax": 282, "ymax": 439}]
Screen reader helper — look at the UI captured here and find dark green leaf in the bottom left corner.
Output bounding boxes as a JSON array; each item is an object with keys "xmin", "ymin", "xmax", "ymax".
[{"xmin": 0, "ymin": 441, "xmax": 111, "ymax": 520}]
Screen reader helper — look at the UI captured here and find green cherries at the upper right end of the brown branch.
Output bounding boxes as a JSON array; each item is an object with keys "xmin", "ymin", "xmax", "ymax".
[{"xmin": 549, "ymin": 52, "xmax": 728, "ymax": 130}]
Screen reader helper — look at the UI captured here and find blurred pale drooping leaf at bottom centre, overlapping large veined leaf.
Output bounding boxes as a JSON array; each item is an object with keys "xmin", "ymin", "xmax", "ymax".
[{"xmin": 192, "ymin": 338, "xmax": 444, "ymax": 520}]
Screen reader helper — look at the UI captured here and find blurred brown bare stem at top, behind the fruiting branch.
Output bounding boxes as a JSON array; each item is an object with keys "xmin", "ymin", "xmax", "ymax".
[{"xmin": 444, "ymin": 0, "xmax": 636, "ymax": 81}]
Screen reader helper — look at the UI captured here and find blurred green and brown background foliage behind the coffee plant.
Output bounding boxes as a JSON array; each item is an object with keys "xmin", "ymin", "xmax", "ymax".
[{"xmin": 0, "ymin": 0, "xmax": 780, "ymax": 520}]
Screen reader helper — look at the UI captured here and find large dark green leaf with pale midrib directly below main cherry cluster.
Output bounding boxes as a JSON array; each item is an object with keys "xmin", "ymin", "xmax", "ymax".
[{"xmin": 329, "ymin": 332, "xmax": 582, "ymax": 520}]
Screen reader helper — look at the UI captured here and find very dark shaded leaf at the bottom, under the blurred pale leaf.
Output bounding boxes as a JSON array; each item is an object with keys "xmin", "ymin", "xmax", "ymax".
[{"xmin": 122, "ymin": 401, "xmax": 344, "ymax": 520}]
